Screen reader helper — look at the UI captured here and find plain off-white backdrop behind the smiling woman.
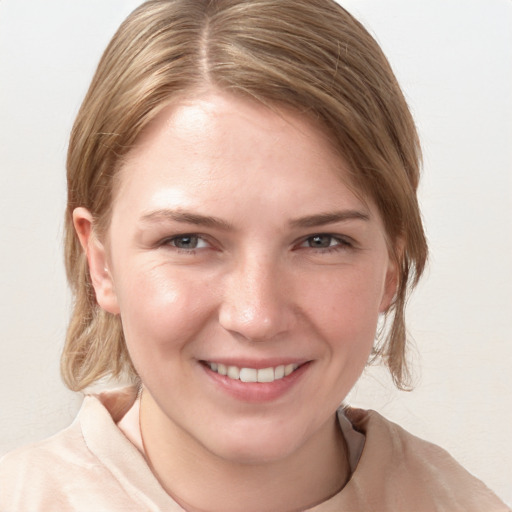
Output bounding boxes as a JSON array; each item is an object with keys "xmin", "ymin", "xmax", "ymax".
[{"xmin": 0, "ymin": 0, "xmax": 512, "ymax": 504}]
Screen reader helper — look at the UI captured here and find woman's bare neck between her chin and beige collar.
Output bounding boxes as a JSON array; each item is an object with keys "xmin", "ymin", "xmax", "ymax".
[{"xmin": 140, "ymin": 392, "xmax": 350, "ymax": 512}]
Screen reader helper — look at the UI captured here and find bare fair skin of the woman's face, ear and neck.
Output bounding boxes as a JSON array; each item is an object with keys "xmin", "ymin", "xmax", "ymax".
[{"xmin": 74, "ymin": 91, "xmax": 397, "ymax": 512}]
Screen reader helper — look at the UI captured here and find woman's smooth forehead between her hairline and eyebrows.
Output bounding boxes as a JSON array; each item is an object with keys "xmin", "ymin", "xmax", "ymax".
[{"xmin": 116, "ymin": 92, "xmax": 374, "ymax": 219}]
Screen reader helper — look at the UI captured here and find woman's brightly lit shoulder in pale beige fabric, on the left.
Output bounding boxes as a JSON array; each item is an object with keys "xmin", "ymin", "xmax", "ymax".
[{"xmin": 0, "ymin": 390, "xmax": 144, "ymax": 512}]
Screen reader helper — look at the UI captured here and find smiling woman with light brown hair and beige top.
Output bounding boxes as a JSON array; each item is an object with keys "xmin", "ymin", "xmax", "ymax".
[{"xmin": 0, "ymin": 0, "xmax": 506, "ymax": 511}]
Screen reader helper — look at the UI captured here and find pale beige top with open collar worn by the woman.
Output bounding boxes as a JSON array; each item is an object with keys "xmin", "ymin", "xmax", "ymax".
[{"xmin": 0, "ymin": 389, "xmax": 510, "ymax": 512}]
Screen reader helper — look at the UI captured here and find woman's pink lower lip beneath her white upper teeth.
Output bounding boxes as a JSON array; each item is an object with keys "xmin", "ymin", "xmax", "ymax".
[{"xmin": 201, "ymin": 362, "xmax": 311, "ymax": 403}]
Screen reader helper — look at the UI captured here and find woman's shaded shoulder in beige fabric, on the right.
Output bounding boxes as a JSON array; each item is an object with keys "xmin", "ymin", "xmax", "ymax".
[{"xmin": 345, "ymin": 408, "xmax": 509, "ymax": 512}]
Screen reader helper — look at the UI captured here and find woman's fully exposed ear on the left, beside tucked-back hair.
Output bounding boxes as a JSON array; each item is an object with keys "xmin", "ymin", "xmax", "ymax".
[{"xmin": 73, "ymin": 207, "xmax": 119, "ymax": 315}]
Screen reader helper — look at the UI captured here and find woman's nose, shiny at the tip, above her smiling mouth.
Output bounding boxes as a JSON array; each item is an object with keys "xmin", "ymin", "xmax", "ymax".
[{"xmin": 219, "ymin": 256, "xmax": 295, "ymax": 341}]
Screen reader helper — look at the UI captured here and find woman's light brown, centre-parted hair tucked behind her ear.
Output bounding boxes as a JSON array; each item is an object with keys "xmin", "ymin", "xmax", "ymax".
[{"xmin": 61, "ymin": 0, "xmax": 427, "ymax": 390}]
